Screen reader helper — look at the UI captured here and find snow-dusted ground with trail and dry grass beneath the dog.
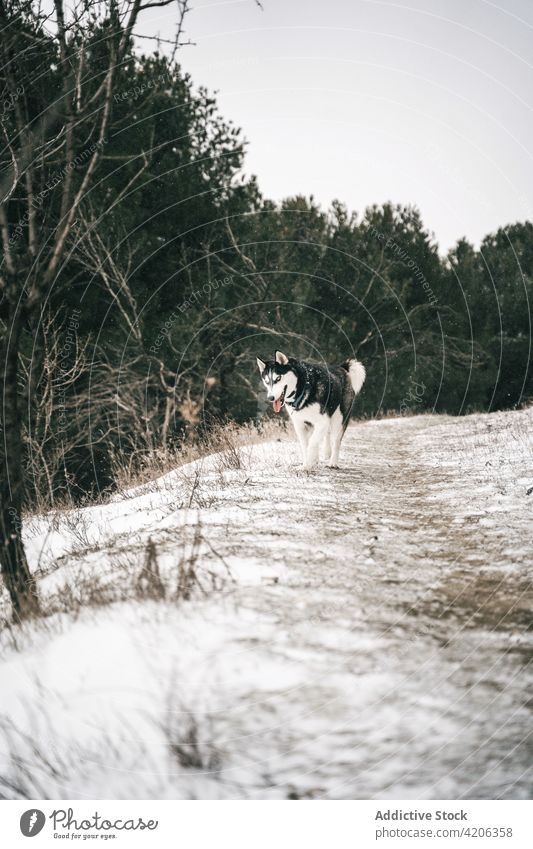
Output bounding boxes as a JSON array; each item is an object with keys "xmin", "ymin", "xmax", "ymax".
[{"xmin": 0, "ymin": 410, "xmax": 533, "ymax": 799}]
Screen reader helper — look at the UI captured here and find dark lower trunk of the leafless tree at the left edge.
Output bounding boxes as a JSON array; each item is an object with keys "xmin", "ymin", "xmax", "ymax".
[{"xmin": 0, "ymin": 307, "xmax": 40, "ymax": 619}]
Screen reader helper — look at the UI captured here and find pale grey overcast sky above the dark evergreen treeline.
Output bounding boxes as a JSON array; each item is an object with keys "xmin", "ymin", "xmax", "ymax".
[{"xmin": 138, "ymin": 0, "xmax": 533, "ymax": 251}]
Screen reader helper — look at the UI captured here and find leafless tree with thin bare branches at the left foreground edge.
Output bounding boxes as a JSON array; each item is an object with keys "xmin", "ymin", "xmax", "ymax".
[{"xmin": 0, "ymin": 0, "xmax": 189, "ymax": 618}]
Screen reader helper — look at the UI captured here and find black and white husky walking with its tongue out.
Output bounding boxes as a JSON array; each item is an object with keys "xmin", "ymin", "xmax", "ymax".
[{"xmin": 257, "ymin": 351, "xmax": 366, "ymax": 469}]
